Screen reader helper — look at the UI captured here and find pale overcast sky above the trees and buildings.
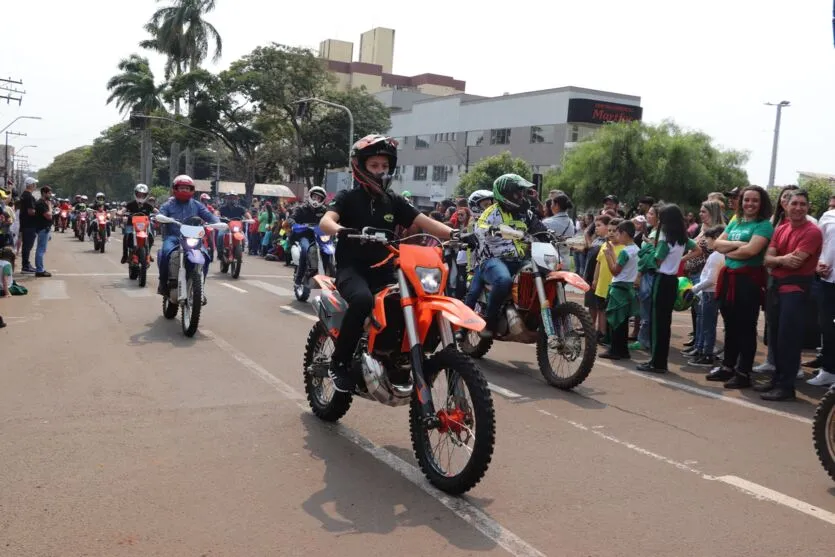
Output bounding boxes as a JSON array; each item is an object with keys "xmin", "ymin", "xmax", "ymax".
[{"xmin": 0, "ymin": 0, "xmax": 835, "ymax": 184}]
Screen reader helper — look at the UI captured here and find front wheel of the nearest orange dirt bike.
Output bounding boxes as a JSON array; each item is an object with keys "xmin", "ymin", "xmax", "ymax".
[{"xmin": 409, "ymin": 347, "xmax": 496, "ymax": 495}]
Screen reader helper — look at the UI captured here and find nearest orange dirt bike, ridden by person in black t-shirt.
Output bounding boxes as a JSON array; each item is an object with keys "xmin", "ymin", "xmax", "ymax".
[{"xmin": 304, "ymin": 228, "xmax": 496, "ymax": 494}]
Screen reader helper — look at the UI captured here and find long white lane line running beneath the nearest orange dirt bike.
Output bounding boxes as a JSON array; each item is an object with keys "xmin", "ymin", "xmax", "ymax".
[{"xmin": 207, "ymin": 328, "xmax": 545, "ymax": 557}]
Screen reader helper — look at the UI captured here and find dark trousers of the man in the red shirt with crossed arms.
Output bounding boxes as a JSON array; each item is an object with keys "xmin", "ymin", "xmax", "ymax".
[{"xmin": 768, "ymin": 292, "xmax": 809, "ymax": 391}]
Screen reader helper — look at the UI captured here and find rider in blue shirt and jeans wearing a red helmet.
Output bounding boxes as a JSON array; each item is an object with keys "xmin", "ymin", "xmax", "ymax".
[{"xmin": 157, "ymin": 174, "xmax": 220, "ymax": 296}]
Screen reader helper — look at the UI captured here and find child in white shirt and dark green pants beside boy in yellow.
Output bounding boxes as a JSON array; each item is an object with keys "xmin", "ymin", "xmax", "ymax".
[{"xmin": 600, "ymin": 220, "xmax": 638, "ymax": 360}]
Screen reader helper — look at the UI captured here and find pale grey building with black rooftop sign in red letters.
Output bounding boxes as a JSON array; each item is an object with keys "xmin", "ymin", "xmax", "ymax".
[{"xmin": 375, "ymin": 87, "xmax": 643, "ymax": 207}]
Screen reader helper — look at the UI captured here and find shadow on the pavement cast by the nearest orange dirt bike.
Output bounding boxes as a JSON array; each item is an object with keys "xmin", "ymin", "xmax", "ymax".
[{"xmin": 301, "ymin": 413, "xmax": 496, "ymax": 551}]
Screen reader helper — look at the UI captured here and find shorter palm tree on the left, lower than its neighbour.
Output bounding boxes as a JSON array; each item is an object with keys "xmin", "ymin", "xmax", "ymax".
[{"xmin": 107, "ymin": 54, "xmax": 165, "ymax": 184}]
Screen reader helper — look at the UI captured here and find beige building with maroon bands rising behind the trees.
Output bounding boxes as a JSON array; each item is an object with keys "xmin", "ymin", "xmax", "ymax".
[{"xmin": 319, "ymin": 27, "xmax": 466, "ymax": 97}]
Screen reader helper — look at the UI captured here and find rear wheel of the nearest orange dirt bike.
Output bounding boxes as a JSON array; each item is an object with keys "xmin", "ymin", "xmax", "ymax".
[{"xmin": 303, "ymin": 323, "xmax": 354, "ymax": 422}]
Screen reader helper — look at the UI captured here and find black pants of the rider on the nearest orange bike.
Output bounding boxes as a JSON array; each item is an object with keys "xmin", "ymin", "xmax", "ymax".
[{"xmin": 333, "ymin": 266, "xmax": 395, "ymax": 364}]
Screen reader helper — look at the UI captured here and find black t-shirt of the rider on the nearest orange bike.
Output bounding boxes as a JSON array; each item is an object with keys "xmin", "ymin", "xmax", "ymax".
[{"xmin": 328, "ymin": 188, "xmax": 420, "ymax": 268}]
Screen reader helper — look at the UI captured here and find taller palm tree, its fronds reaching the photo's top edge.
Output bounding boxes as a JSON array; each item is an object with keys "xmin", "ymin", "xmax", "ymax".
[{"xmin": 140, "ymin": 0, "xmax": 223, "ymax": 176}]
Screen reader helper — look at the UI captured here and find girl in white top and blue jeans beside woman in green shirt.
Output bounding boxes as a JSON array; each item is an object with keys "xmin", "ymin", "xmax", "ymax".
[{"xmin": 688, "ymin": 225, "xmax": 725, "ymax": 367}]
